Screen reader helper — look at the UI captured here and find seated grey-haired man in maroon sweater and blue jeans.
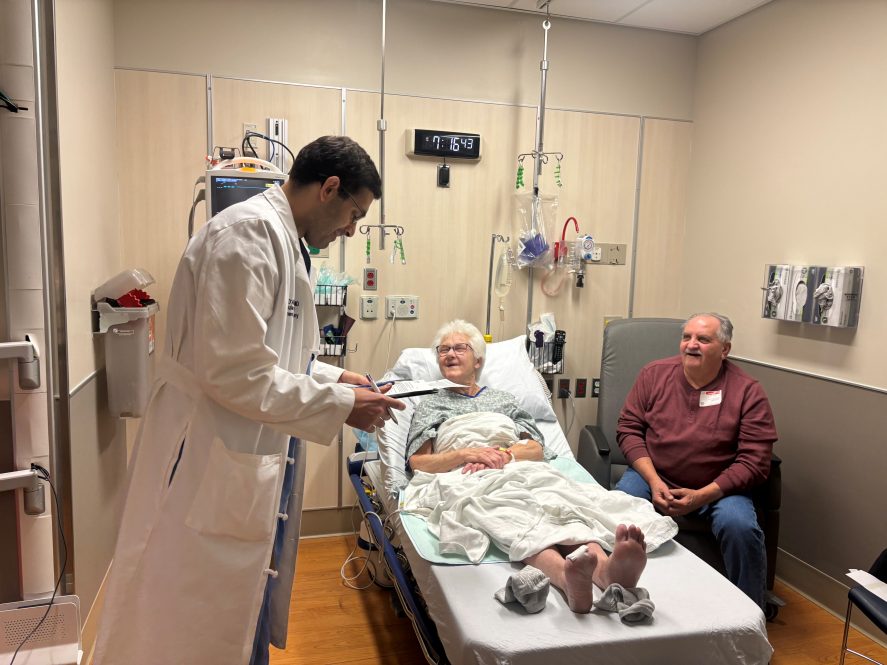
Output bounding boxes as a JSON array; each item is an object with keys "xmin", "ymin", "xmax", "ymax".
[{"xmin": 616, "ymin": 313, "xmax": 777, "ymax": 607}]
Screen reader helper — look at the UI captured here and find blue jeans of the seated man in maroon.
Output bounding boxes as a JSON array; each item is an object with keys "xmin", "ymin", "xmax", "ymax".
[{"xmin": 616, "ymin": 468, "xmax": 767, "ymax": 608}]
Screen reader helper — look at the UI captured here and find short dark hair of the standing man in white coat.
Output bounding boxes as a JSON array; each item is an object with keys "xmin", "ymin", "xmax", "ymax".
[{"xmin": 289, "ymin": 136, "xmax": 382, "ymax": 199}]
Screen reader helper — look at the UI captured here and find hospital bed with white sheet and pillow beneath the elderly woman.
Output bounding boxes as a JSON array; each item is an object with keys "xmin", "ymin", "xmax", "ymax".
[{"xmin": 349, "ymin": 338, "xmax": 772, "ymax": 665}]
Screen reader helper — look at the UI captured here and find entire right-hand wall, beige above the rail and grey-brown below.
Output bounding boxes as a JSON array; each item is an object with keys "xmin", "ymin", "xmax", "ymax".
[{"xmin": 680, "ymin": 0, "xmax": 887, "ymax": 612}]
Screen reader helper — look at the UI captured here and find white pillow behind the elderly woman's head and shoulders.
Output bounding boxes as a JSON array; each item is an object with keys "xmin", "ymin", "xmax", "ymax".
[{"xmin": 377, "ymin": 336, "xmax": 557, "ymax": 496}]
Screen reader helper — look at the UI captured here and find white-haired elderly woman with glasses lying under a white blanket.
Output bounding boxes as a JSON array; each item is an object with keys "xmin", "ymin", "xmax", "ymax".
[{"xmin": 404, "ymin": 320, "xmax": 677, "ymax": 619}]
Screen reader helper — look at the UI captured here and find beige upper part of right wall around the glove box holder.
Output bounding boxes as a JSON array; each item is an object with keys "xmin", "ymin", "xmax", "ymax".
[{"xmin": 681, "ymin": 0, "xmax": 887, "ymax": 388}]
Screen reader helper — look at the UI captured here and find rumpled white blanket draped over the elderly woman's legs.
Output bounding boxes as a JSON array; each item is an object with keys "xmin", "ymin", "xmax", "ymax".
[{"xmin": 401, "ymin": 462, "xmax": 678, "ymax": 563}]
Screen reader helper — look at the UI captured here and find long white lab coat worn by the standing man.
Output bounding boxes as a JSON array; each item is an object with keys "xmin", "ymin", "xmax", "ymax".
[{"xmin": 94, "ymin": 187, "xmax": 354, "ymax": 665}]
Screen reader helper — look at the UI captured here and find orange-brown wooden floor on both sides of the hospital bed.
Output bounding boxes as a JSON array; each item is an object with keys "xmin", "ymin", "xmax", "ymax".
[{"xmin": 271, "ymin": 536, "xmax": 887, "ymax": 665}]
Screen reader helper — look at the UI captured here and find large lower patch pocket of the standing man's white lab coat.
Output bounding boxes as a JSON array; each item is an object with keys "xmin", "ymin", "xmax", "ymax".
[{"xmin": 185, "ymin": 437, "xmax": 280, "ymax": 541}]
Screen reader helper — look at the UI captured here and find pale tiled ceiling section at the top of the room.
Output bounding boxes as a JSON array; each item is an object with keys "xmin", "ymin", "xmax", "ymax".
[{"xmin": 436, "ymin": 0, "xmax": 770, "ymax": 35}]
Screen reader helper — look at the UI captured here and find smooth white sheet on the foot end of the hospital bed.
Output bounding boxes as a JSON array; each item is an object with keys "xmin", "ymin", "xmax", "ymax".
[{"xmin": 366, "ymin": 456, "xmax": 773, "ymax": 665}]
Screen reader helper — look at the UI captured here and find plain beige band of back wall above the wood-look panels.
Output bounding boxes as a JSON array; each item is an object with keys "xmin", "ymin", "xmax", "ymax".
[{"xmin": 114, "ymin": 0, "xmax": 696, "ymax": 119}]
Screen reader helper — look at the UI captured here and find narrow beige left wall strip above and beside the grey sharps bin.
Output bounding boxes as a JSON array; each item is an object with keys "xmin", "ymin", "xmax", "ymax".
[{"xmin": 56, "ymin": 0, "xmax": 123, "ymax": 388}]
